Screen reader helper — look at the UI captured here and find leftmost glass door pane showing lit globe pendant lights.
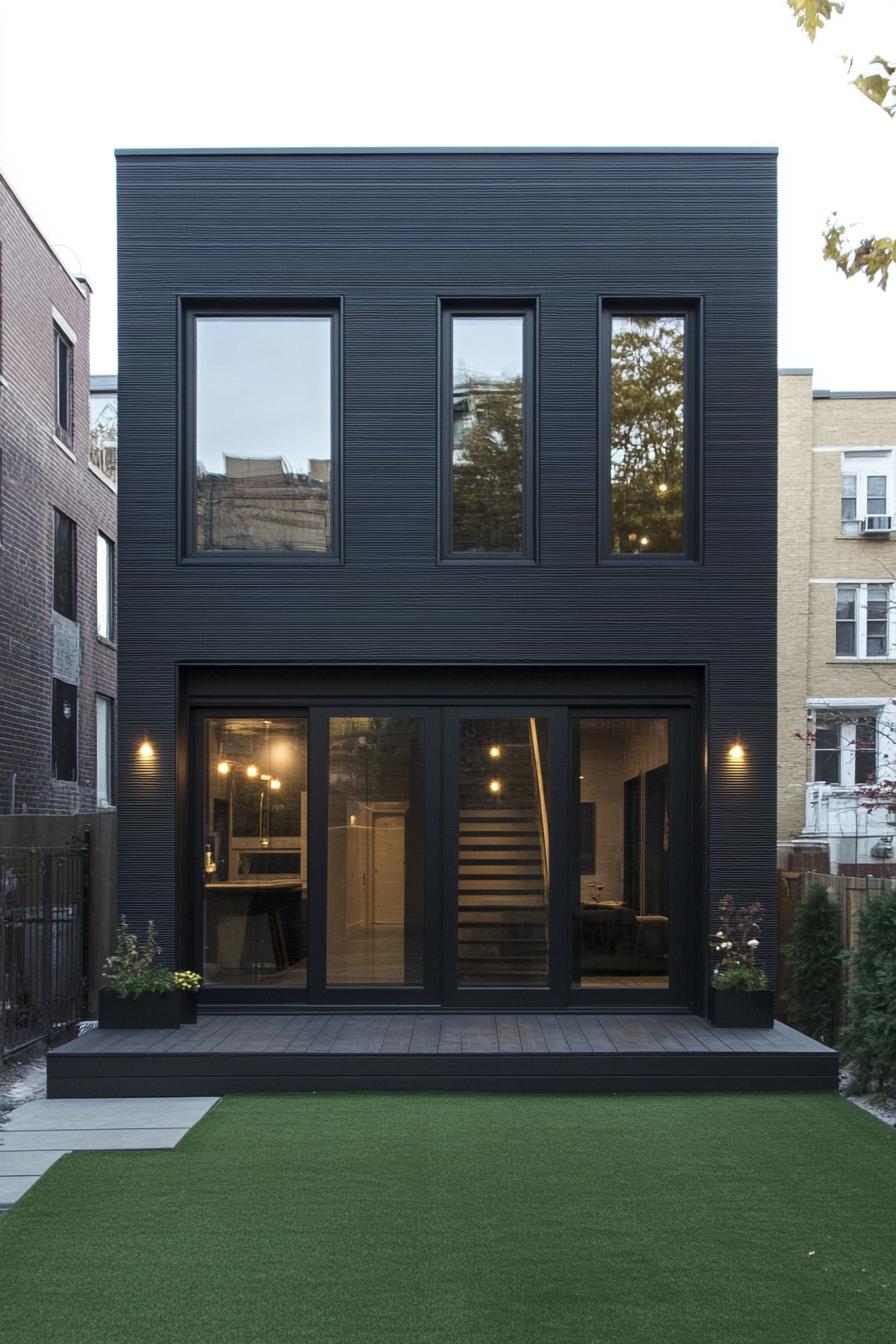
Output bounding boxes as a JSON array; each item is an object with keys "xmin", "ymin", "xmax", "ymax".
[{"xmin": 201, "ymin": 718, "xmax": 308, "ymax": 986}]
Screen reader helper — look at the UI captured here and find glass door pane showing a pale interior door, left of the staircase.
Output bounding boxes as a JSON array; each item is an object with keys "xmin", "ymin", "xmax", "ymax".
[{"xmin": 326, "ymin": 715, "xmax": 424, "ymax": 986}]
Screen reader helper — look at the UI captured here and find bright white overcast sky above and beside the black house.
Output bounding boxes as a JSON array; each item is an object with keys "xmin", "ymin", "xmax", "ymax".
[{"xmin": 0, "ymin": 0, "xmax": 896, "ymax": 390}]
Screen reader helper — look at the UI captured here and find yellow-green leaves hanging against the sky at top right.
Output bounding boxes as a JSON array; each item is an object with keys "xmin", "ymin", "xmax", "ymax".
[{"xmin": 787, "ymin": 0, "xmax": 896, "ymax": 289}]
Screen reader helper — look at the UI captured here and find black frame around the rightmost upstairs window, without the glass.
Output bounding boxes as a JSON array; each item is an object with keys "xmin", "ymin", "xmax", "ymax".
[{"xmin": 598, "ymin": 294, "xmax": 704, "ymax": 570}]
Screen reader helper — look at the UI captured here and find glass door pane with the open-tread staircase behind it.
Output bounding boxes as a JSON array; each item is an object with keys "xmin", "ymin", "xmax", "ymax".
[{"xmin": 457, "ymin": 715, "xmax": 551, "ymax": 988}]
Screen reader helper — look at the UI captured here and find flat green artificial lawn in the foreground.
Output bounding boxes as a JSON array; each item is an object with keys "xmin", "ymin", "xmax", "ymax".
[{"xmin": 0, "ymin": 1093, "xmax": 896, "ymax": 1344}]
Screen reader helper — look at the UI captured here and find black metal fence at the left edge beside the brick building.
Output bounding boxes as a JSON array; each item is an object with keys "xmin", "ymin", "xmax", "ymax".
[{"xmin": 0, "ymin": 837, "xmax": 90, "ymax": 1059}]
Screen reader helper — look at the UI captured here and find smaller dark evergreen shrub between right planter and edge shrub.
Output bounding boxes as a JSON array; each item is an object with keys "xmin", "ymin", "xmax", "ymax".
[{"xmin": 787, "ymin": 882, "xmax": 844, "ymax": 1046}]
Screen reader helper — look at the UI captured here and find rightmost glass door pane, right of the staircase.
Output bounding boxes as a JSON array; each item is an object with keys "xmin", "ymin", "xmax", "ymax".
[{"xmin": 572, "ymin": 716, "xmax": 670, "ymax": 989}]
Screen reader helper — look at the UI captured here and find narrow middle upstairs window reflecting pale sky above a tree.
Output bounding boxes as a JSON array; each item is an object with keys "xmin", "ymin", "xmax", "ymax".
[{"xmin": 442, "ymin": 308, "xmax": 535, "ymax": 559}]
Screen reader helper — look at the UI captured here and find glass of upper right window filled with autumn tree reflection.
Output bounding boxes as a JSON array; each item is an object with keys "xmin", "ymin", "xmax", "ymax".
[{"xmin": 610, "ymin": 316, "xmax": 685, "ymax": 555}]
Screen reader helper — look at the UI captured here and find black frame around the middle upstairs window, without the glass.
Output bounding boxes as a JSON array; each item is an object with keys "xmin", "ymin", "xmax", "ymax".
[{"xmin": 438, "ymin": 296, "xmax": 539, "ymax": 566}]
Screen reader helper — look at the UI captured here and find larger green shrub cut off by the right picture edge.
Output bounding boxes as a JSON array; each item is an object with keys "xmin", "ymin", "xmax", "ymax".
[{"xmin": 840, "ymin": 891, "xmax": 896, "ymax": 1094}]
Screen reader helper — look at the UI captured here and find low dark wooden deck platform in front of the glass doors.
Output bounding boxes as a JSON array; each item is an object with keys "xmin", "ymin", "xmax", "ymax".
[{"xmin": 47, "ymin": 1011, "xmax": 838, "ymax": 1097}]
